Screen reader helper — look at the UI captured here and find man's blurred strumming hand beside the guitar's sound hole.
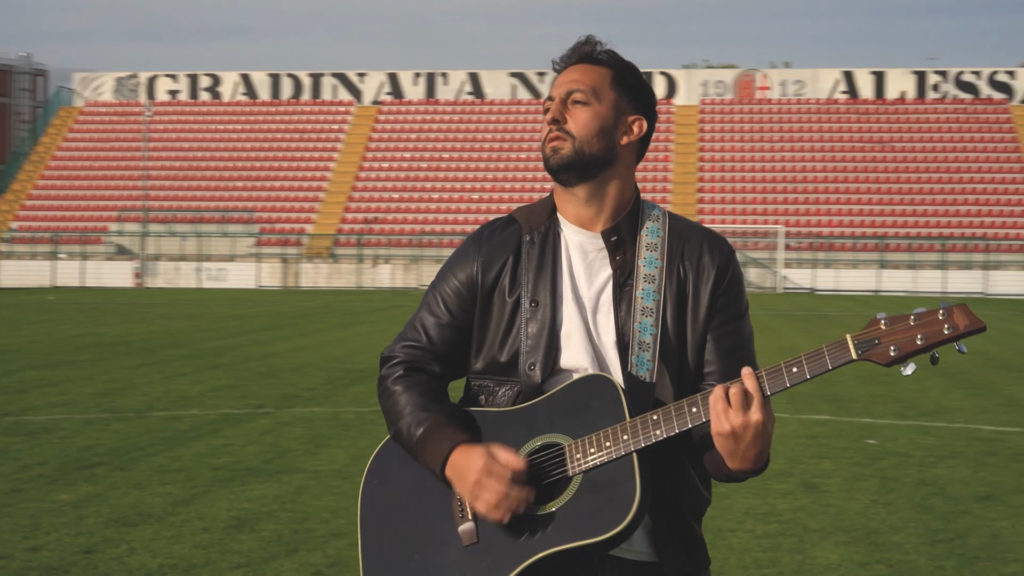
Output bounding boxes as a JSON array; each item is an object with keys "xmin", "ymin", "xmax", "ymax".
[{"xmin": 444, "ymin": 443, "xmax": 534, "ymax": 524}]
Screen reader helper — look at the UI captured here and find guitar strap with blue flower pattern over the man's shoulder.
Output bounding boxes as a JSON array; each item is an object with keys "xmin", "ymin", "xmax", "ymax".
[{"xmin": 627, "ymin": 200, "xmax": 669, "ymax": 411}]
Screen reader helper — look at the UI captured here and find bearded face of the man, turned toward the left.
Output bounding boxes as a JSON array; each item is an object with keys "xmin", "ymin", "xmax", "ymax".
[{"xmin": 541, "ymin": 65, "xmax": 620, "ymax": 188}]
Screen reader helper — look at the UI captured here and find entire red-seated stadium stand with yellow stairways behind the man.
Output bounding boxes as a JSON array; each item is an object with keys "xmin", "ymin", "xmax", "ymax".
[{"xmin": 0, "ymin": 98, "xmax": 1024, "ymax": 256}]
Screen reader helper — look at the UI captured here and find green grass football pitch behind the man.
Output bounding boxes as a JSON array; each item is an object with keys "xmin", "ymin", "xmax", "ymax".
[{"xmin": 0, "ymin": 290, "xmax": 1024, "ymax": 576}]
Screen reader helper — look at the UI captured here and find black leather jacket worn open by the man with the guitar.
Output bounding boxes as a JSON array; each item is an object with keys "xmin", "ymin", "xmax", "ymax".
[{"xmin": 378, "ymin": 193, "xmax": 756, "ymax": 574}]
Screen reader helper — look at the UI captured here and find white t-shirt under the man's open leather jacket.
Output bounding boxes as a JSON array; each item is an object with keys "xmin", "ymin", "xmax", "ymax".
[{"xmin": 545, "ymin": 214, "xmax": 657, "ymax": 561}]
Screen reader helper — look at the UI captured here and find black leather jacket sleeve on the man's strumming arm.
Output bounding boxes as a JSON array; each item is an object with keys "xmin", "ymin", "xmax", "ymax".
[{"xmin": 377, "ymin": 239, "xmax": 479, "ymax": 480}]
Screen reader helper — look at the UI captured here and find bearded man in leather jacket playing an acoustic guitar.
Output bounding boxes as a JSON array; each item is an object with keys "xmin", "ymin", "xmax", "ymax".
[{"xmin": 378, "ymin": 36, "xmax": 774, "ymax": 575}]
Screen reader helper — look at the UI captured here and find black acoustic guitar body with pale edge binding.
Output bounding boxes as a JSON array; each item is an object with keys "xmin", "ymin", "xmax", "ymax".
[{"xmin": 359, "ymin": 374, "xmax": 640, "ymax": 576}]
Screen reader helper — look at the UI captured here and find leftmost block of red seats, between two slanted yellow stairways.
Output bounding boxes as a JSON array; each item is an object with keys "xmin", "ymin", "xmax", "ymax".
[{"xmin": 11, "ymin": 100, "xmax": 354, "ymax": 251}]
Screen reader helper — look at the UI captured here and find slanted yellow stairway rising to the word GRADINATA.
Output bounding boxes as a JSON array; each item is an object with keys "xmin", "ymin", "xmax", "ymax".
[{"xmin": 305, "ymin": 106, "xmax": 380, "ymax": 257}]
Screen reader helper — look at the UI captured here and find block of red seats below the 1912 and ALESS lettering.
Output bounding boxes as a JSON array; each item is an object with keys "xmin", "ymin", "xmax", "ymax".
[{"xmin": 698, "ymin": 98, "xmax": 1024, "ymax": 251}]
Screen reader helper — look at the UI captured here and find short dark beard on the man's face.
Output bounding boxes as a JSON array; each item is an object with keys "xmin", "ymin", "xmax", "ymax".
[{"xmin": 541, "ymin": 122, "xmax": 618, "ymax": 188}]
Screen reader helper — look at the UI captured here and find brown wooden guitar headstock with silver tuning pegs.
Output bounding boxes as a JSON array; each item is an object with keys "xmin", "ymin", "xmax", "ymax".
[{"xmin": 850, "ymin": 304, "xmax": 985, "ymax": 366}]
